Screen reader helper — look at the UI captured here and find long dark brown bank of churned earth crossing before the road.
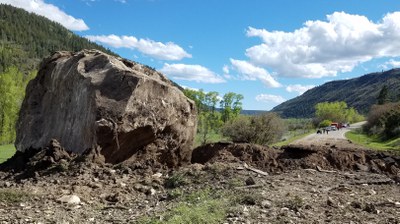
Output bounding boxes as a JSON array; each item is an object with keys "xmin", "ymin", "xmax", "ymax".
[{"xmin": 192, "ymin": 143, "xmax": 400, "ymax": 176}]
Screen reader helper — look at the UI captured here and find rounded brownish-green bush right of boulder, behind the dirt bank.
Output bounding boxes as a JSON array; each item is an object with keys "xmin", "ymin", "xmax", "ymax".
[{"xmin": 222, "ymin": 113, "xmax": 285, "ymax": 145}]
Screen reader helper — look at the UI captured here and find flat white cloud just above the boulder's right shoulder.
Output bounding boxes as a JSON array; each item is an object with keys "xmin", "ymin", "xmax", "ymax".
[{"xmin": 160, "ymin": 63, "xmax": 225, "ymax": 83}]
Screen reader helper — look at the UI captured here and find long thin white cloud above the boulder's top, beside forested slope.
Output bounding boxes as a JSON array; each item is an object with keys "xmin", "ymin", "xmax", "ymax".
[{"xmin": 86, "ymin": 34, "xmax": 192, "ymax": 61}]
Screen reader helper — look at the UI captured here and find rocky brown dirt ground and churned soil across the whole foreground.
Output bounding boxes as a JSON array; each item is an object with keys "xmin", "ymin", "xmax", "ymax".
[{"xmin": 0, "ymin": 140, "xmax": 400, "ymax": 224}]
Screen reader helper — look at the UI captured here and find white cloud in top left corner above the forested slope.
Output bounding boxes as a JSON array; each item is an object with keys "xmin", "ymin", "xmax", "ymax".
[{"xmin": 0, "ymin": 0, "xmax": 89, "ymax": 31}]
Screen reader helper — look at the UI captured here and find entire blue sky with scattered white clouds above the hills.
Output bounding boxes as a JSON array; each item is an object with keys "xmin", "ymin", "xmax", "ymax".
[{"xmin": 0, "ymin": 0, "xmax": 400, "ymax": 110}]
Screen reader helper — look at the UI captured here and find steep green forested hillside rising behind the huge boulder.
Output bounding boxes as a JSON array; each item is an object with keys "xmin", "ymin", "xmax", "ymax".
[{"xmin": 0, "ymin": 4, "xmax": 115, "ymax": 73}]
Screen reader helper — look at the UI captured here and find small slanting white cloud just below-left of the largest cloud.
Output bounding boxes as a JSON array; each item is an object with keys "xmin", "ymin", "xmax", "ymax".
[{"xmin": 230, "ymin": 58, "xmax": 281, "ymax": 88}]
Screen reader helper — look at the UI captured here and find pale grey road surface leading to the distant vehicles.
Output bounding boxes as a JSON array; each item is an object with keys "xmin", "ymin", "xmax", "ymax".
[{"xmin": 291, "ymin": 121, "xmax": 365, "ymax": 146}]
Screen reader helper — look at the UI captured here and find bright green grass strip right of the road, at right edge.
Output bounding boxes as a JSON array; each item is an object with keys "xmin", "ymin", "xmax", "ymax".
[{"xmin": 346, "ymin": 131, "xmax": 400, "ymax": 152}]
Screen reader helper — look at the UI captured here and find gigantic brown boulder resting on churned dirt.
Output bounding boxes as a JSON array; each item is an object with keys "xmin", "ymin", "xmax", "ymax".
[{"xmin": 16, "ymin": 50, "xmax": 196, "ymax": 167}]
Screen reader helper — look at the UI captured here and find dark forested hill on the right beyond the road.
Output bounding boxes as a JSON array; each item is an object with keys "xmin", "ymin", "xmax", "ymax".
[{"xmin": 272, "ymin": 69, "xmax": 400, "ymax": 118}]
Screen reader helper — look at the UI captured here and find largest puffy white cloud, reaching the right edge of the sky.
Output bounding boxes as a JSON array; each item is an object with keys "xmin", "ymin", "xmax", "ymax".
[{"xmin": 246, "ymin": 12, "xmax": 400, "ymax": 78}]
